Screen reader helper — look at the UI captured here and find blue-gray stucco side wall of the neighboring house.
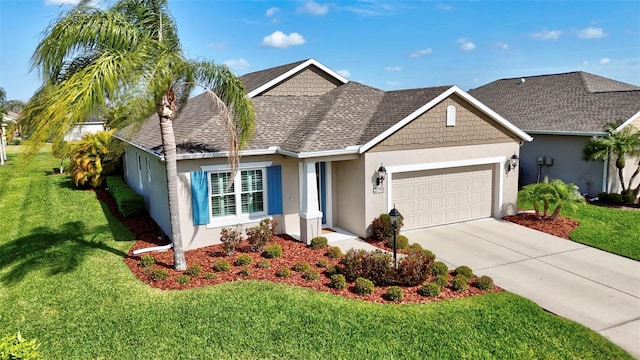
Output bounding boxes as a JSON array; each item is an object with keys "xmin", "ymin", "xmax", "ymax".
[{"xmin": 520, "ymin": 134, "xmax": 605, "ymax": 196}]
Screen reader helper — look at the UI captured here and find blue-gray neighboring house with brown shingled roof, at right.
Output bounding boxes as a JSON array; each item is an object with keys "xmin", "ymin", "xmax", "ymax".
[{"xmin": 469, "ymin": 72, "xmax": 640, "ymax": 196}]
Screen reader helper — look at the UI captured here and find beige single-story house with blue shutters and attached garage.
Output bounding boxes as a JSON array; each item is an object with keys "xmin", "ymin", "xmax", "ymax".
[{"xmin": 117, "ymin": 59, "xmax": 531, "ymax": 250}]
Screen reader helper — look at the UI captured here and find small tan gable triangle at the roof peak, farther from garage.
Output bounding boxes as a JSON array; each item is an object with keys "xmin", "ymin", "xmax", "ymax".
[{"xmin": 262, "ymin": 66, "xmax": 340, "ymax": 96}]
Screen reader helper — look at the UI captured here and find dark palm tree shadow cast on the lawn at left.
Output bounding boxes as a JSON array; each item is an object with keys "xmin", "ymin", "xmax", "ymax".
[{"xmin": 0, "ymin": 221, "xmax": 126, "ymax": 285}]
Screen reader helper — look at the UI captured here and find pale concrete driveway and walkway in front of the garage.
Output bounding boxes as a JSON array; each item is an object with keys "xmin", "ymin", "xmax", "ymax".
[{"xmin": 332, "ymin": 219, "xmax": 640, "ymax": 359}]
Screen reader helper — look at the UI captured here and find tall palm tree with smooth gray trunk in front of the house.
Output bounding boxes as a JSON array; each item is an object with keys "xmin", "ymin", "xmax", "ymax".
[{"xmin": 16, "ymin": 0, "xmax": 254, "ymax": 270}]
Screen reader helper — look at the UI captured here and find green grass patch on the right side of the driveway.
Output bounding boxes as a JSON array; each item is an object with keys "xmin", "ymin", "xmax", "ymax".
[{"xmin": 518, "ymin": 201, "xmax": 640, "ymax": 261}]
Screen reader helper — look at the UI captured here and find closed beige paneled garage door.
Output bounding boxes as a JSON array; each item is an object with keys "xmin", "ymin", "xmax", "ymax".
[{"xmin": 392, "ymin": 165, "xmax": 493, "ymax": 230}]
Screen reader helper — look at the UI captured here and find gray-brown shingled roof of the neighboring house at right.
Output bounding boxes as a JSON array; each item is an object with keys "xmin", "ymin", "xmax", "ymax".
[{"xmin": 469, "ymin": 71, "xmax": 640, "ymax": 135}]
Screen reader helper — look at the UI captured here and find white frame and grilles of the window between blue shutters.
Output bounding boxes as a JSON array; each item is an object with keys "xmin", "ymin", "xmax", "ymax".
[{"xmin": 200, "ymin": 161, "xmax": 271, "ymax": 228}]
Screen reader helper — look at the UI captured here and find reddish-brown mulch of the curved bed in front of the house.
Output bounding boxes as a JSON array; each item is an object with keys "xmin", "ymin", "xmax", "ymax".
[{"xmin": 96, "ymin": 190, "xmax": 502, "ymax": 304}]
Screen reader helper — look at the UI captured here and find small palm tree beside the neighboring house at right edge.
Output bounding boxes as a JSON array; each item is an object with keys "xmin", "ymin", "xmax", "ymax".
[{"xmin": 582, "ymin": 123, "xmax": 640, "ymax": 194}]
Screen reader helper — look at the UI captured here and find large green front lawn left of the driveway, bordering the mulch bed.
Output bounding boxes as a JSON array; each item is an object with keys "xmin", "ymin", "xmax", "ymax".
[{"xmin": 0, "ymin": 147, "xmax": 631, "ymax": 359}]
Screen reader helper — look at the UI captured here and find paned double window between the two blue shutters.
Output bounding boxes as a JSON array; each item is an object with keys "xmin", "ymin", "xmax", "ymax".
[{"xmin": 209, "ymin": 169, "xmax": 265, "ymax": 218}]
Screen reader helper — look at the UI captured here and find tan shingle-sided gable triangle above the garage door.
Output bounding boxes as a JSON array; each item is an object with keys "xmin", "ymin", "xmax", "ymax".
[{"xmin": 369, "ymin": 95, "xmax": 516, "ymax": 152}]
